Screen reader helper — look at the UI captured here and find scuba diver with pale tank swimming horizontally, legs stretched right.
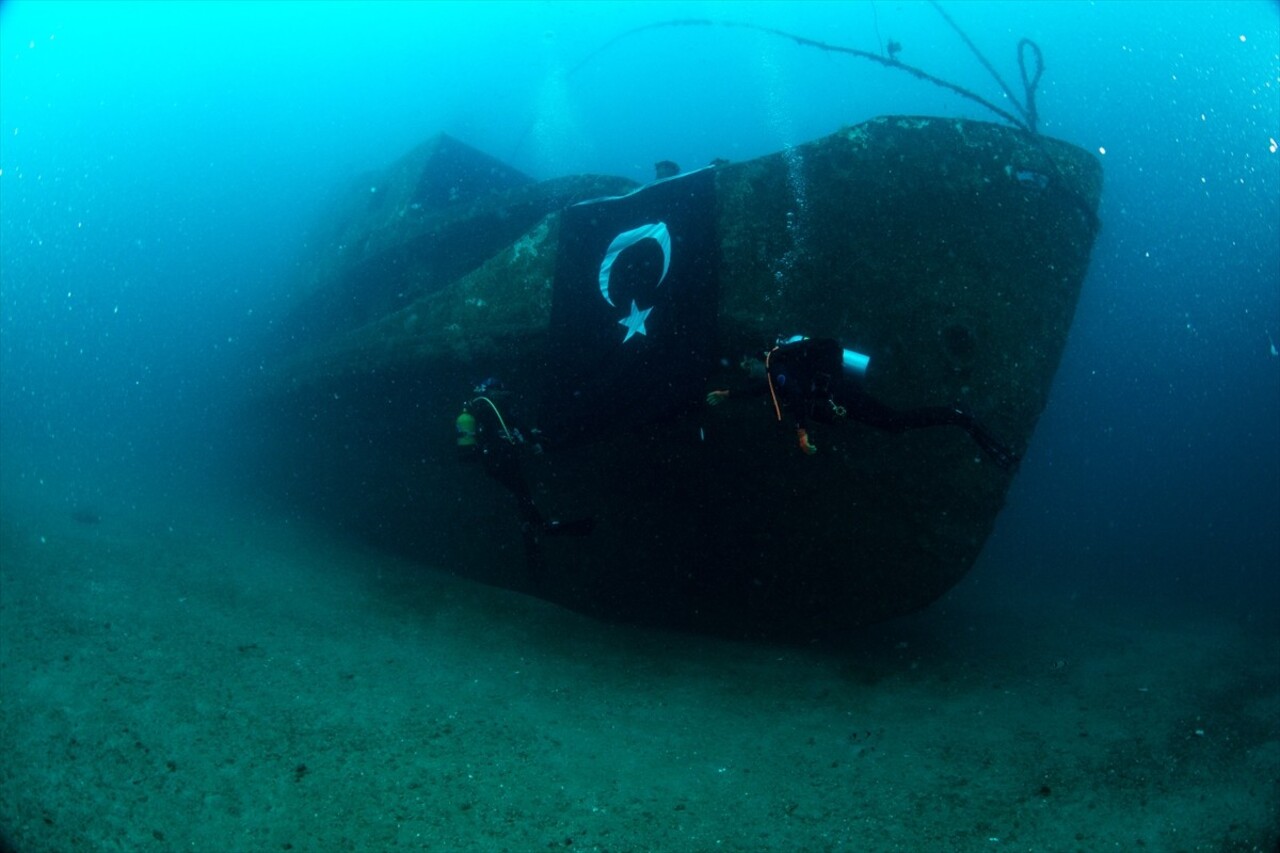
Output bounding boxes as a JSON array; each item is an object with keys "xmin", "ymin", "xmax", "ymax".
[{"xmin": 707, "ymin": 334, "xmax": 1020, "ymax": 469}]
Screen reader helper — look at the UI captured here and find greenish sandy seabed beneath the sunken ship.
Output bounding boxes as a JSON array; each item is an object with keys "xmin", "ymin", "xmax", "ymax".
[{"xmin": 0, "ymin": 492, "xmax": 1280, "ymax": 853}]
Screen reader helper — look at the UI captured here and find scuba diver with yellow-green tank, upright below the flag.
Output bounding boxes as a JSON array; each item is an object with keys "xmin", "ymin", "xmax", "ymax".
[{"xmin": 454, "ymin": 379, "xmax": 595, "ymax": 584}]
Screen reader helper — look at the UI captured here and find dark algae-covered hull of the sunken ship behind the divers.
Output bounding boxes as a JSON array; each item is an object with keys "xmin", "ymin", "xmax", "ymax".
[{"xmin": 259, "ymin": 118, "xmax": 1101, "ymax": 635}]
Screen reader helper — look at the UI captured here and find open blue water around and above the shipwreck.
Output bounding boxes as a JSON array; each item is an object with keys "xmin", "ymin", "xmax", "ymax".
[{"xmin": 0, "ymin": 0, "xmax": 1280, "ymax": 613}]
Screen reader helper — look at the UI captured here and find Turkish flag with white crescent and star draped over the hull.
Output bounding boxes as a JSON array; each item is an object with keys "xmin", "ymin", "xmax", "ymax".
[{"xmin": 539, "ymin": 168, "xmax": 719, "ymax": 447}]
